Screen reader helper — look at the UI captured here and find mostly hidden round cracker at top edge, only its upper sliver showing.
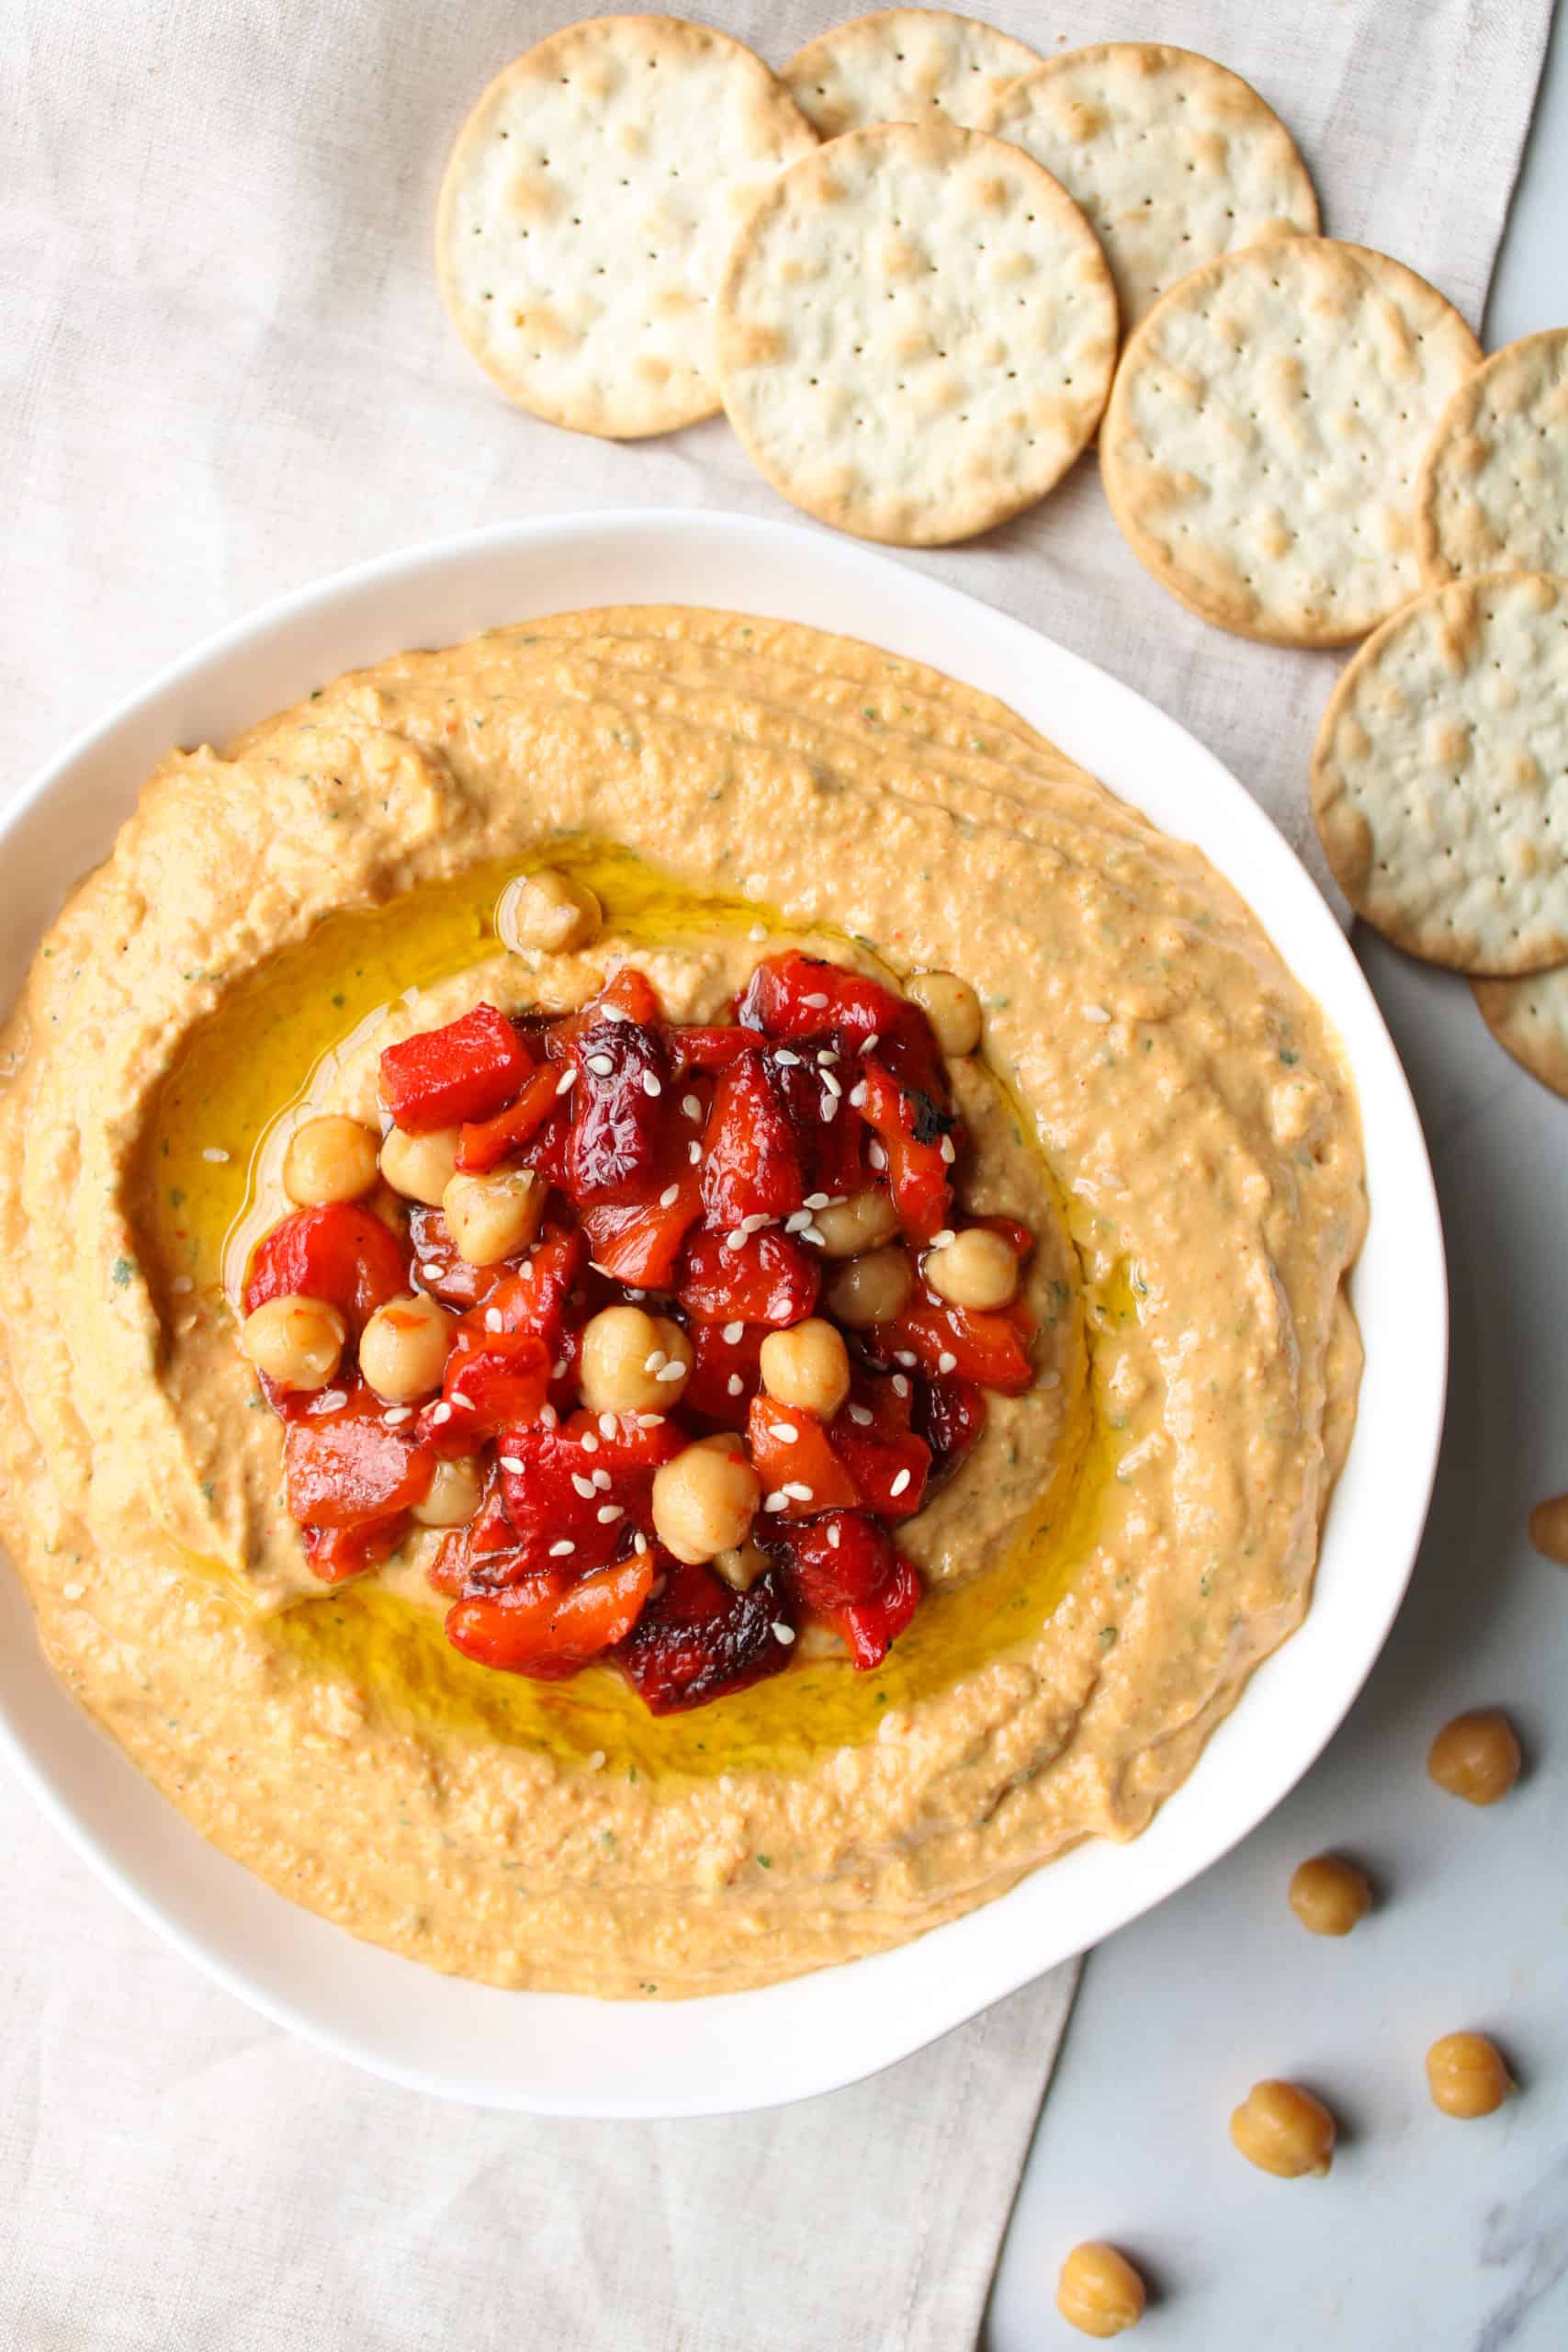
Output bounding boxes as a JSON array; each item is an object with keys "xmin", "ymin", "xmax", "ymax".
[{"xmin": 783, "ymin": 7, "xmax": 1039, "ymax": 139}]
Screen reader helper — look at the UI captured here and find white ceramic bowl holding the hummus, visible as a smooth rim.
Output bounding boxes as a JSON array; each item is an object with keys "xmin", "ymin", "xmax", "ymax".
[{"xmin": 0, "ymin": 513, "xmax": 1446, "ymax": 2117}]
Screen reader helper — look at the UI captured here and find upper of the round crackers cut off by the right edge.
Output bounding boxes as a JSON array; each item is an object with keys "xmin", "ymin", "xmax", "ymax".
[{"xmin": 1416, "ymin": 327, "xmax": 1568, "ymax": 585}]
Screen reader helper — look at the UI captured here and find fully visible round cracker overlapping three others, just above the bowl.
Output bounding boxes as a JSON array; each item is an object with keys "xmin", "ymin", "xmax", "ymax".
[{"xmin": 717, "ymin": 122, "xmax": 1117, "ymax": 548}]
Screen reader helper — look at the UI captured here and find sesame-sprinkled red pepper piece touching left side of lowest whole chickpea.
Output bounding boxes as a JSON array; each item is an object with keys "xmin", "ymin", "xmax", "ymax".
[{"xmin": 493, "ymin": 1414, "xmax": 686, "ymax": 1576}]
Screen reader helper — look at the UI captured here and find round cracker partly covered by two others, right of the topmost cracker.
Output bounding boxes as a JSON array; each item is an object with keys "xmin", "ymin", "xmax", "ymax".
[{"xmin": 980, "ymin": 40, "xmax": 1319, "ymax": 332}]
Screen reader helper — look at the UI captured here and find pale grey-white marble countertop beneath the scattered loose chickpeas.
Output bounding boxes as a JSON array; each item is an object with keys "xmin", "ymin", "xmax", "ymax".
[{"xmin": 985, "ymin": 0, "xmax": 1568, "ymax": 2352}]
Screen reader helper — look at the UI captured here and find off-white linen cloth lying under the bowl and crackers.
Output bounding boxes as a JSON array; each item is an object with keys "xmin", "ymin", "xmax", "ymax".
[{"xmin": 0, "ymin": 0, "xmax": 1550, "ymax": 2352}]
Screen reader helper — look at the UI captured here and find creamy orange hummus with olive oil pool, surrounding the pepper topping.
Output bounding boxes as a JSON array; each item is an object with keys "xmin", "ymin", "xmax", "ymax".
[{"xmin": 0, "ymin": 606, "xmax": 1366, "ymax": 1996}]
